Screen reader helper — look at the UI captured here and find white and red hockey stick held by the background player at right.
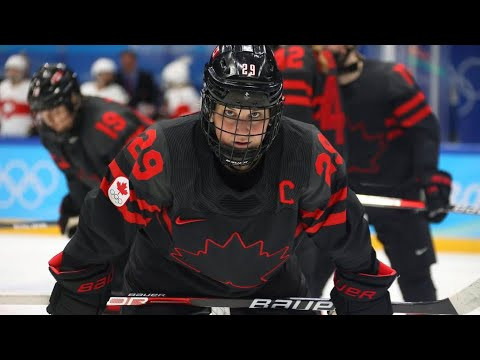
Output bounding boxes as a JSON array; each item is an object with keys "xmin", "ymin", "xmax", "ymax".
[{"xmin": 357, "ymin": 194, "xmax": 480, "ymax": 215}]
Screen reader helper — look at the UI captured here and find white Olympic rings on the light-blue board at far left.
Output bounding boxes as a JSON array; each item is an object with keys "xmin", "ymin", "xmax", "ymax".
[{"xmin": 0, "ymin": 159, "xmax": 59, "ymax": 210}]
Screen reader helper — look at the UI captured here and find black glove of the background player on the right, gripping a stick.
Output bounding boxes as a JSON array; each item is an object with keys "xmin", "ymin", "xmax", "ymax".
[{"xmin": 424, "ymin": 170, "xmax": 452, "ymax": 223}]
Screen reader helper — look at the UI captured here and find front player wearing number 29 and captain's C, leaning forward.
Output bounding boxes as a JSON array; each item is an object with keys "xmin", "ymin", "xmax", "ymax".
[{"xmin": 47, "ymin": 45, "xmax": 396, "ymax": 314}]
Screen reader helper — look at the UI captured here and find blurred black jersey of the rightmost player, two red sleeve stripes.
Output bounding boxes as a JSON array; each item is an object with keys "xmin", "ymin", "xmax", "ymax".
[{"xmin": 341, "ymin": 60, "xmax": 439, "ymax": 198}]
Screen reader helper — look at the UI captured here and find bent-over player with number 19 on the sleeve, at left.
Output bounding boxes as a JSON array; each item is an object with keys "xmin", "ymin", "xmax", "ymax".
[{"xmin": 28, "ymin": 63, "xmax": 153, "ymax": 294}]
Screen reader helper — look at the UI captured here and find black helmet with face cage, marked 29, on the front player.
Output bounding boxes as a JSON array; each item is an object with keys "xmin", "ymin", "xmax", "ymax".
[{"xmin": 201, "ymin": 45, "xmax": 283, "ymax": 167}]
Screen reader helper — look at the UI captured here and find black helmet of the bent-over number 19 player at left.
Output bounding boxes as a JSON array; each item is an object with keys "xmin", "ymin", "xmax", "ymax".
[{"xmin": 28, "ymin": 63, "xmax": 80, "ymax": 112}]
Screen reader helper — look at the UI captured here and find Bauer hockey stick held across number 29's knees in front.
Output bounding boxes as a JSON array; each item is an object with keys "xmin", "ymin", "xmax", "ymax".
[{"xmin": 0, "ymin": 279, "xmax": 480, "ymax": 315}]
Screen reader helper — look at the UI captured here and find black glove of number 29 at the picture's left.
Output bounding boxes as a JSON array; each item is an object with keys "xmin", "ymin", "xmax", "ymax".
[{"xmin": 47, "ymin": 252, "xmax": 113, "ymax": 315}]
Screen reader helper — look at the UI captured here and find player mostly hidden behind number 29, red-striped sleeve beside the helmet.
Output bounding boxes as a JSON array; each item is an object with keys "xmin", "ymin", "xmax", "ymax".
[{"xmin": 275, "ymin": 45, "xmax": 348, "ymax": 297}]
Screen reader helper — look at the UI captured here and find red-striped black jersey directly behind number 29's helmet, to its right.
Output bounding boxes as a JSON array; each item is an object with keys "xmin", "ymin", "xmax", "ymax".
[{"xmin": 275, "ymin": 45, "xmax": 347, "ymax": 158}]
